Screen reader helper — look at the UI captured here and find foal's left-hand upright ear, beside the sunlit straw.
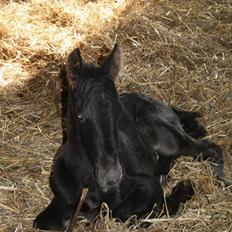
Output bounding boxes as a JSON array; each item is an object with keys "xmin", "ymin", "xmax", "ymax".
[{"xmin": 66, "ymin": 48, "xmax": 83, "ymax": 89}]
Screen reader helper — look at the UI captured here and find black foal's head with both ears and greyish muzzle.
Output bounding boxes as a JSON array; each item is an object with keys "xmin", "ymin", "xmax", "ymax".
[{"xmin": 67, "ymin": 44, "xmax": 122, "ymax": 190}]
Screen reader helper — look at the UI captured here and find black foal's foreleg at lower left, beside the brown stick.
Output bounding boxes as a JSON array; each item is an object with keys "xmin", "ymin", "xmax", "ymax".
[{"xmin": 34, "ymin": 154, "xmax": 81, "ymax": 231}]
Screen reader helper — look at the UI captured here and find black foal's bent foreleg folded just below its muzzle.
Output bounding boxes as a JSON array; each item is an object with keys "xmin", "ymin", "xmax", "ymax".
[{"xmin": 109, "ymin": 174, "xmax": 164, "ymax": 221}]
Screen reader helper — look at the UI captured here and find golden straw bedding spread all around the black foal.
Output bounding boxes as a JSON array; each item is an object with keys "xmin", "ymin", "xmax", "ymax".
[{"xmin": 0, "ymin": 0, "xmax": 232, "ymax": 232}]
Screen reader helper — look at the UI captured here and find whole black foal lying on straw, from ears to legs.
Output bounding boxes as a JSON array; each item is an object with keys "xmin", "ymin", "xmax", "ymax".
[{"xmin": 35, "ymin": 46, "xmax": 229, "ymax": 230}]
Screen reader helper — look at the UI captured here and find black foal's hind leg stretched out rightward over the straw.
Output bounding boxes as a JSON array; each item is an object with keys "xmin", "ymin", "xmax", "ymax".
[{"xmin": 154, "ymin": 122, "xmax": 231, "ymax": 186}]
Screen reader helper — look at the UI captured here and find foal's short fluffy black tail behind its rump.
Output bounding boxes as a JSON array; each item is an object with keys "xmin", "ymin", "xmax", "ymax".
[{"xmin": 172, "ymin": 108, "xmax": 207, "ymax": 139}]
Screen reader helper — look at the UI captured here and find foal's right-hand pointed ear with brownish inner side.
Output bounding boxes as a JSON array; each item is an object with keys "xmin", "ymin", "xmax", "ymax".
[{"xmin": 102, "ymin": 43, "xmax": 121, "ymax": 81}]
